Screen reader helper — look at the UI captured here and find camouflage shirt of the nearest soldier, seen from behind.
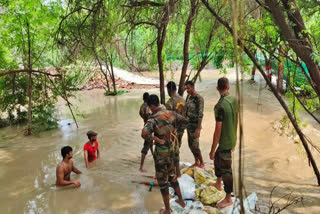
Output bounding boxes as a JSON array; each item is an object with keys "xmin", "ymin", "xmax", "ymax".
[{"xmin": 143, "ymin": 109, "xmax": 187, "ymax": 147}]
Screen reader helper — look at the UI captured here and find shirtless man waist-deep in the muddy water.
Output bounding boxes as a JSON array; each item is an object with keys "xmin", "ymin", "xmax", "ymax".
[{"xmin": 56, "ymin": 146, "xmax": 81, "ymax": 187}]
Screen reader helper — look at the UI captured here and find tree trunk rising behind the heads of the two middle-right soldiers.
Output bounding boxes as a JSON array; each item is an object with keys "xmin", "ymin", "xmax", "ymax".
[{"xmin": 178, "ymin": 0, "xmax": 198, "ymax": 96}]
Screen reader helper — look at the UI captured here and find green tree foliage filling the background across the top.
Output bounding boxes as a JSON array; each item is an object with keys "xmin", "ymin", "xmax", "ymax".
[{"xmin": 0, "ymin": 0, "xmax": 320, "ymax": 134}]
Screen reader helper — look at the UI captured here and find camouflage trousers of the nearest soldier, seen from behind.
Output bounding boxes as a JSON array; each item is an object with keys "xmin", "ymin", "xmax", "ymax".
[{"xmin": 154, "ymin": 142, "xmax": 177, "ymax": 189}]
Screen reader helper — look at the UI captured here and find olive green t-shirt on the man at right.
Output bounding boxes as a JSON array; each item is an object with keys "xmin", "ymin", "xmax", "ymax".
[{"xmin": 214, "ymin": 93, "xmax": 238, "ymax": 151}]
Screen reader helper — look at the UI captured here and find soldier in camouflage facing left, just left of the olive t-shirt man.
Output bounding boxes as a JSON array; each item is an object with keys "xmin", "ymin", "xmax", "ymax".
[{"xmin": 186, "ymin": 81, "xmax": 204, "ymax": 168}]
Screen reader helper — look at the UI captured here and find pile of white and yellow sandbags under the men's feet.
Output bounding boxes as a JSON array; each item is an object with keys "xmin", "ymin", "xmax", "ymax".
[{"xmin": 170, "ymin": 163, "xmax": 258, "ymax": 214}]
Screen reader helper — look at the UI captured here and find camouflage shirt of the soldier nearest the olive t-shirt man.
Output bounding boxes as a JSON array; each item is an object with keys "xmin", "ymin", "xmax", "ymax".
[{"xmin": 186, "ymin": 94, "xmax": 204, "ymax": 123}]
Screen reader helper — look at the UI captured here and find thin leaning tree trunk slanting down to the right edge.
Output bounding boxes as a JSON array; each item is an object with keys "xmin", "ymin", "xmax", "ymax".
[{"xmin": 202, "ymin": 0, "xmax": 320, "ymax": 186}]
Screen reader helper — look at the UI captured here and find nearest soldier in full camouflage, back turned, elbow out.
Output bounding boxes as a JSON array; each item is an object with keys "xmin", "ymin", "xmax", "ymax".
[{"xmin": 141, "ymin": 94, "xmax": 187, "ymax": 214}]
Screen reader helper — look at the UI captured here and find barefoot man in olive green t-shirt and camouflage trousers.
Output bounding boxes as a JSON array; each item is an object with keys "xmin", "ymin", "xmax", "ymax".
[{"xmin": 209, "ymin": 77, "xmax": 238, "ymax": 208}]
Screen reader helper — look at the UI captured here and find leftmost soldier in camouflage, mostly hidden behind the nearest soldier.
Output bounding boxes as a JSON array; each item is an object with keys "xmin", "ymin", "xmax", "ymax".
[{"xmin": 139, "ymin": 92, "xmax": 153, "ymax": 172}]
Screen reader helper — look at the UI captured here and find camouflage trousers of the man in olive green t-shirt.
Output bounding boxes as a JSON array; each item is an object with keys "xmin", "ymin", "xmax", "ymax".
[{"xmin": 214, "ymin": 150, "xmax": 233, "ymax": 194}]
